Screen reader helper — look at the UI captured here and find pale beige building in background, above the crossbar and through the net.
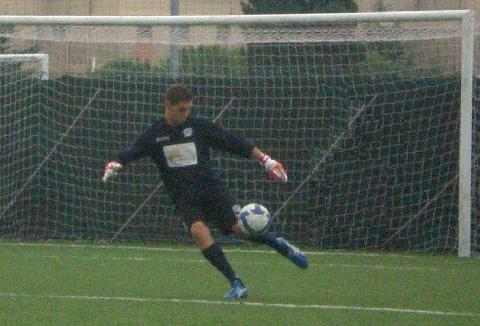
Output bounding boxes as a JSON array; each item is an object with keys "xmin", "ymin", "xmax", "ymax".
[{"xmin": 0, "ymin": 0, "xmax": 480, "ymax": 72}]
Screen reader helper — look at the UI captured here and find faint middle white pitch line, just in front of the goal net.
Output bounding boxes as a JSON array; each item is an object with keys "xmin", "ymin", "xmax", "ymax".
[{"xmin": 14, "ymin": 255, "xmax": 464, "ymax": 273}]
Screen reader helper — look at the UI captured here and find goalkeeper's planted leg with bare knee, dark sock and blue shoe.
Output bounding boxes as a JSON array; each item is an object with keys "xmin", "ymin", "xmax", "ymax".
[{"xmin": 190, "ymin": 220, "xmax": 248, "ymax": 299}]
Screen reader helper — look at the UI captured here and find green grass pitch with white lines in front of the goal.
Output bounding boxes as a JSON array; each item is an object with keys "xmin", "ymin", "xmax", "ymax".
[{"xmin": 0, "ymin": 242, "xmax": 480, "ymax": 325}]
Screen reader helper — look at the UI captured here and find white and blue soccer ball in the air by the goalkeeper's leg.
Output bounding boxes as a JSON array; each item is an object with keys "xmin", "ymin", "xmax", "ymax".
[{"xmin": 238, "ymin": 203, "xmax": 270, "ymax": 237}]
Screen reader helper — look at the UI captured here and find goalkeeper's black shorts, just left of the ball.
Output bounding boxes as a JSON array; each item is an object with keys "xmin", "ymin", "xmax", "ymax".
[{"xmin": 175, "ymin": 189, "xmax": 239, "ymax": 234}]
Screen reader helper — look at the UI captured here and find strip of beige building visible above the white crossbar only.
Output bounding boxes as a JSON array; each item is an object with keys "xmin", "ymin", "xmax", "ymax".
[{"xmin": 0, "ymin": 0, "xmax": 480, "ymax": 17}]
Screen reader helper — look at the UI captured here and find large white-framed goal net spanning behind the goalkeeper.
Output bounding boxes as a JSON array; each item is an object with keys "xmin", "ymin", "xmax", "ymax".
[{"xmin": 0, "ymin": 11, "xmax": 479, "ymax": 252}]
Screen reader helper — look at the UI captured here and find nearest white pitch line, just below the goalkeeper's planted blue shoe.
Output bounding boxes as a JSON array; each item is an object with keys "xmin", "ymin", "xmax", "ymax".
[{"xmin": 0, "ymin": 292, "xmax": 480, "ymax": 317}]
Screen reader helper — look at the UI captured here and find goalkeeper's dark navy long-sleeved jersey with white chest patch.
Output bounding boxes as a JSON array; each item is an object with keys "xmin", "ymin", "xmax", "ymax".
[{"xmin": 114, "ymin": 117, "xmax": 253, "ymax": 202}]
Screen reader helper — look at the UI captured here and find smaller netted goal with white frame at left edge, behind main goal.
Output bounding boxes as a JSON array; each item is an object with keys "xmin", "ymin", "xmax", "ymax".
[{"xmin": 0, "ymin": 54, "xmax": 48, "ymax": 236}]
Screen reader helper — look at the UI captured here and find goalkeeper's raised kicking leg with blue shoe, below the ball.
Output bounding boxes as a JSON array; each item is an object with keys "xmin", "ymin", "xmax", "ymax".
[{"xmin": 232, "ymin": 222, "xmax": 308, "ymax": 269}]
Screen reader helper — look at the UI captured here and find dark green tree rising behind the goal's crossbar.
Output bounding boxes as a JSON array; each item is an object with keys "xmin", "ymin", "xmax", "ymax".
[{"xmin": 242, "ymin": 0, "xmax": 365, "ymax": 91}]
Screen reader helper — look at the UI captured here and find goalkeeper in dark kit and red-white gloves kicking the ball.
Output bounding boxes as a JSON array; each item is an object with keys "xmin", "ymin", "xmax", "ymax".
[{"xmin": 103, "ymin": 84, "xmax": 308, "ymax": 299}]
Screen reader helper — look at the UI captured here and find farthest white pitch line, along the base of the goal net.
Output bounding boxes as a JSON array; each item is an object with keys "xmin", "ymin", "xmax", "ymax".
[{"xmin": 0, "ymin": 241, "xmax": 421, "ymax": 259}]
